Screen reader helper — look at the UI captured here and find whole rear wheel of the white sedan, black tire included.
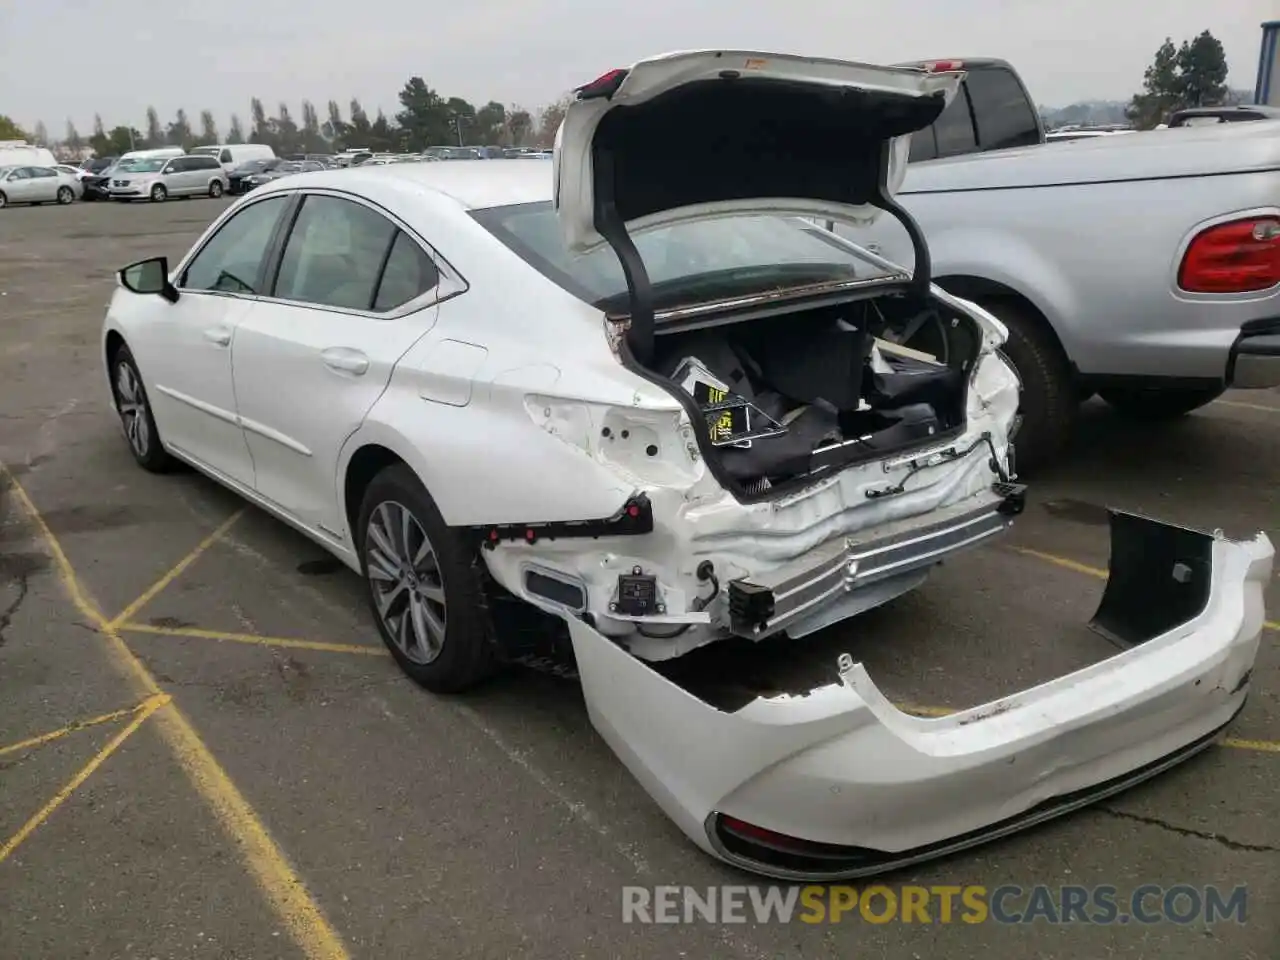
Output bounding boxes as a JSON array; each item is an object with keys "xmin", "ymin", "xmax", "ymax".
[{"xmin": 363, "ymin": 465, "xmax": 498, "ymax": 694}]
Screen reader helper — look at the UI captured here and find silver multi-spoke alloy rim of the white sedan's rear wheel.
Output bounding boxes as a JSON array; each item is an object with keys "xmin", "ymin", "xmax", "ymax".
[{"xmin": 365, "ymin": 500, "xmax": 447, "ymax": 664}]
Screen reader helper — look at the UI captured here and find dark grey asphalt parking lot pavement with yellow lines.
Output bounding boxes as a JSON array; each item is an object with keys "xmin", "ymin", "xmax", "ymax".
[{"xmin": 0, "ymin": 200, "xmax": 1280, "ymax": 960}]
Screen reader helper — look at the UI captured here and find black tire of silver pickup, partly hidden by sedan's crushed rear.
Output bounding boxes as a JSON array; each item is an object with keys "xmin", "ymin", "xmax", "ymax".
[{"xmin": 978, "ymin": 298, "xmax": 1080, "ymax": 472}]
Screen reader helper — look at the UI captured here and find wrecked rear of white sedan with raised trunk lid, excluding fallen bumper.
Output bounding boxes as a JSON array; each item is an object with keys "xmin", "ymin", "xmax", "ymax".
[{"xmin": 472, "ymin": 51, "xmax": 1023, "ymax": 660}]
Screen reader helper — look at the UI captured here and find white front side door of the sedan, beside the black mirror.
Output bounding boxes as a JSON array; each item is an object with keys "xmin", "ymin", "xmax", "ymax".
[{"xmin": 131, "ymin": 196, "xmax": 288, "ymax": 488}]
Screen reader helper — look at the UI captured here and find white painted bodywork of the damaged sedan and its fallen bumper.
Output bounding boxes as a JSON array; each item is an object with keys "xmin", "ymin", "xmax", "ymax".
[{"xmin": 104, "ymin": 50, "xmax": 1272, "ymax": 876}]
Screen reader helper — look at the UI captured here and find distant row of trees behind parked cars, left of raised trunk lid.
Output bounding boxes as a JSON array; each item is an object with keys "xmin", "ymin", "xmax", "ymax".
[{"xmin": 0, "ymin": 77, "xmax": 568, "ymax": 156}]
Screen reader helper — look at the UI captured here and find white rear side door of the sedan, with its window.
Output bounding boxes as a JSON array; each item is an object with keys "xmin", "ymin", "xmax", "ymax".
[{"xmin": 233, "ymin": 192, "xmax": 450, "ymax": 539}]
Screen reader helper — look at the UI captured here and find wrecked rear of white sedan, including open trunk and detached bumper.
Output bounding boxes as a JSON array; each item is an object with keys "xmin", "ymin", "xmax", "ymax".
[{"xmin": 499, "ymin": 51, "xmax": 1274, "ymax": 879}]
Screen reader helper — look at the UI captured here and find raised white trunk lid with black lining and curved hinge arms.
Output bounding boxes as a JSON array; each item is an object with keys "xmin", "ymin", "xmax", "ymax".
[{"xmin": 553, "ymin": 50, "xmax": 963, "ymax": 361}]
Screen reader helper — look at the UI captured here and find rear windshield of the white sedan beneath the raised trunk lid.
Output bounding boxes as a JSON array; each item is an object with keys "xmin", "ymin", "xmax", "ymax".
[{"xmin": 472, "ymin": 202, "xmax": 888, "ymax": 306}]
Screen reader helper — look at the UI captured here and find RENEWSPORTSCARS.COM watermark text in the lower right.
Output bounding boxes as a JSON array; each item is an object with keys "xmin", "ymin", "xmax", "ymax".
[{"xmin": 622, "ymin": 883, "xmax": 1248, "ymax": 924}]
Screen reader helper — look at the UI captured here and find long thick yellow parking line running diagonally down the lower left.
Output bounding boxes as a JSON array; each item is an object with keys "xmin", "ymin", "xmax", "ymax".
[{"xmin": 0, "ymin": 463, "xmax": 349, "ymax": 960}]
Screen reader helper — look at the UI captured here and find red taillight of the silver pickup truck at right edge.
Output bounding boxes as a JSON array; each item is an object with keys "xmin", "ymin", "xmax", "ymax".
[{"xmin": 1178, "ymin": 216, "xmax": 1280, "ymax": 293}]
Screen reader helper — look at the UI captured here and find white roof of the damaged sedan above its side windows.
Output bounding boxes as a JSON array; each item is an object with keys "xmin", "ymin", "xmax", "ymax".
[{"xmin": 262, "ymin": 159, "xmax": 552, "ymax": 210}]
